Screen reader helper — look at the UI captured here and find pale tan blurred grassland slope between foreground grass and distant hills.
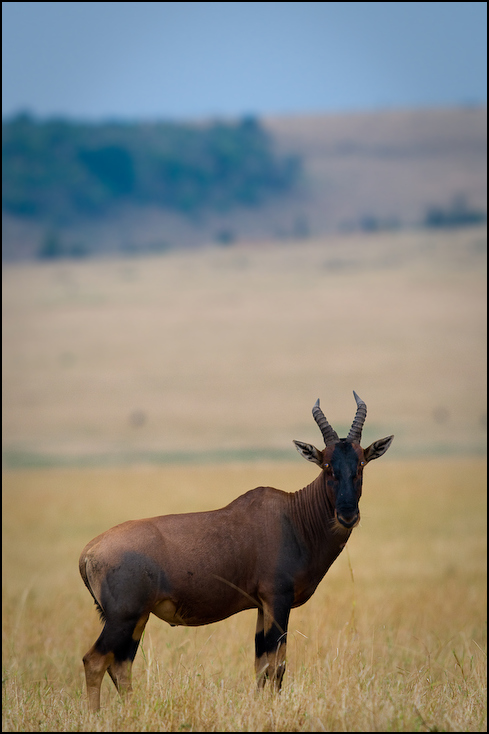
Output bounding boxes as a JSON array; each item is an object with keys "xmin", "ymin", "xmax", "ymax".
[{"xmin": 3, "ymin": 228, "xmax": 486, "ymax": 467}]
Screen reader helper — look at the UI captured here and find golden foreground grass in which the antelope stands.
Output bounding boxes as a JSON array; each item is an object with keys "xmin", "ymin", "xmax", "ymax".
[{"xmin": 2, "ymin": 457, "xmax": 487, "ymax": 731}]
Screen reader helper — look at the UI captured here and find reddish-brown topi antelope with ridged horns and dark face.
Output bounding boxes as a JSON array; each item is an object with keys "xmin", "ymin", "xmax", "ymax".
[{"xmin": 80, "ymin": 392, "xmax": 393, "ymax": 711}]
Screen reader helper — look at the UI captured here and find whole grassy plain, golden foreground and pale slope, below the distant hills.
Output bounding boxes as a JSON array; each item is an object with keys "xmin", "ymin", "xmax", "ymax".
[{"xmin": 2, "ymin": 229, "xmax": 487, "ymax": 731}]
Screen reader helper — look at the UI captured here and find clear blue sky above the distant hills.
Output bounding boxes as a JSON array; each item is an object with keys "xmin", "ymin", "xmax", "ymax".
[{"xmin": 2, "ymin": 2, "xmax": 487, "ymax": 120}]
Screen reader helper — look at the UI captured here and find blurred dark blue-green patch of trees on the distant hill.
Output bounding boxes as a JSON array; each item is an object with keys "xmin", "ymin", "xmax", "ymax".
[{"xmin": 2, "ymin": 114, "xmax": 300, "ymax": 225}]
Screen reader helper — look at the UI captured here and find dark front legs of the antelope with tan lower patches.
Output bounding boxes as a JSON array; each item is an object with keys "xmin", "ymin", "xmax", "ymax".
[{"xmin": 255, "ymin": 603, "xmax": 290, "ymax": 691}]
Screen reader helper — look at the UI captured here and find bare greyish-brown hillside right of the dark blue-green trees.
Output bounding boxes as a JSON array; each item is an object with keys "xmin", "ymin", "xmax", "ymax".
[{"xmin": 264, "ymin": 109, "xmax": 487, "ymax": 232}]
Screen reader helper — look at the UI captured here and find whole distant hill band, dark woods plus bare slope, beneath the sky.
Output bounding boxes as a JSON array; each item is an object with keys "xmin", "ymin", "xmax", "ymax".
[{"xmin": 2, "ymin": 107, "xmax": 487, "ymax": 262}]
